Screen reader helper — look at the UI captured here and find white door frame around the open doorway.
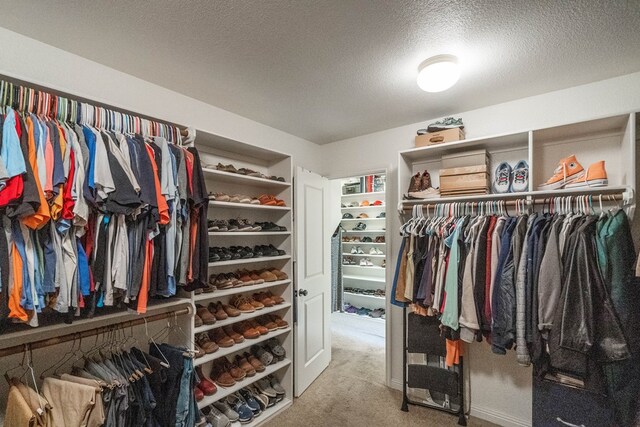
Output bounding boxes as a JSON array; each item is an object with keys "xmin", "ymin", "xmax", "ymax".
[{"xmin": 327, "ymin": 165, "xmax": 396, "ymax": 388}]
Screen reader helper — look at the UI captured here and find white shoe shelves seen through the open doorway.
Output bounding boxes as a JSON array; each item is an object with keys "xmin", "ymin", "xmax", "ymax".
[{"xmin": 340, "ymin": 174, "xmax": 387, "ymax": 321}]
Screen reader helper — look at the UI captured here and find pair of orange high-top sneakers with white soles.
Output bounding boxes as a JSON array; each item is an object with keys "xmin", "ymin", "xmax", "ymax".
[{"xmin": 538, "ymin": 155, "xmax": 609, "ymax": 190}]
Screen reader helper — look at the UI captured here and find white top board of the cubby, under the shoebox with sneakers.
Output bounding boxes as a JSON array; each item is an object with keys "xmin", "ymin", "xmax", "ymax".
[{"xmin": 400, "ymin": 132, "xmax": 529, "ymax": 161}]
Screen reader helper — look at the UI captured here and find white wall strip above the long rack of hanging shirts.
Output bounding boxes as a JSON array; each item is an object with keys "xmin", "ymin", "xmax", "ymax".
[{"xmin": 0, "ymin": 28, "xmax": 321, "ymax": 170}]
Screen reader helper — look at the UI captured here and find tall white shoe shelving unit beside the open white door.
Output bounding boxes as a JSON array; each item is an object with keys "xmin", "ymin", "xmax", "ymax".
[{"xmin": 191, "ymin": 132, "xmax": 293, "ymax": 418}]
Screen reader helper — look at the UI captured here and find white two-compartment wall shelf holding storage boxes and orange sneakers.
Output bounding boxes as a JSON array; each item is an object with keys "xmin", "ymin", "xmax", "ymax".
[{"xmin": 398, "ymin": 113, "xmax": 636, "ymax": 213}]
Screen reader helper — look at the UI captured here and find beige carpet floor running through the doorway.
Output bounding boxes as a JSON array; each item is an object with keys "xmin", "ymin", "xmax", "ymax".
[{"xmin": 265, "ymin": 314, "xmax": 493, "ymax": 427}]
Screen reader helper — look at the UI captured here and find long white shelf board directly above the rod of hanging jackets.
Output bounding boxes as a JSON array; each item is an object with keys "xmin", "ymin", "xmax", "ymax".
[{"xmin": 400, "ymin": 185, "xmax": 628, "ymax": 206}]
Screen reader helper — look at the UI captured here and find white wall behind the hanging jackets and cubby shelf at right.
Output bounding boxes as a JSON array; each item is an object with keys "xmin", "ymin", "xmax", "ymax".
[{"xmin": 322, "ymin": 72, "xmax": 640, "ymax": 425}]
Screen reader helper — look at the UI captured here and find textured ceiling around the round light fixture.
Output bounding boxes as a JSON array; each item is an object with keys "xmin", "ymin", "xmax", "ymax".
[{"xmin": 0, "ymin": 0, "xmax": 640, "ymax": 144}]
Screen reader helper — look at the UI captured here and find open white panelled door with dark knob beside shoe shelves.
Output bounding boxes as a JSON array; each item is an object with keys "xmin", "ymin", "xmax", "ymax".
[{"xmin": 294, "ymin": 167, "xmax": 331, "ymax": 396}]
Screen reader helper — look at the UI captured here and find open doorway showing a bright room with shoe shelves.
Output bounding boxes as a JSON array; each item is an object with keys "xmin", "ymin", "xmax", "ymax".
[{"xmin": 331, "ymin": 170, "xmax": 390, "ymax": 385}]
